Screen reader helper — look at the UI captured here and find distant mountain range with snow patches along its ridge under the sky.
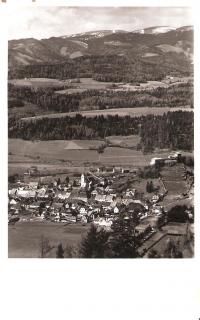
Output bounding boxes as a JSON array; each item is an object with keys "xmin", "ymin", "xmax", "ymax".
[{"xmin": 8, "ymin": 26, "xmax": 193, "ymax": 68}]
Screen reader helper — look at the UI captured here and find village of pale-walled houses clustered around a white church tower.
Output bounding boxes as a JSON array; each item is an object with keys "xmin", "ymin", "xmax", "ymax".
[{"xmin": 8, "ymin": 153, "xmax": 194, "ymax": 255}]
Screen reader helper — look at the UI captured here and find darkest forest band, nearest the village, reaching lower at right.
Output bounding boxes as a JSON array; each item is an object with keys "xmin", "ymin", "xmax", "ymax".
[{"xmin": 9, "ymin": 111, "xmax": 194, "ymax": 152}]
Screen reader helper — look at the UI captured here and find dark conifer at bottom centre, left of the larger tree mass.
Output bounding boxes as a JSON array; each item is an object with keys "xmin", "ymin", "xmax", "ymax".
[{"xmin": 79, "ymin": 224, "xmax": 109, "ymax": 258}]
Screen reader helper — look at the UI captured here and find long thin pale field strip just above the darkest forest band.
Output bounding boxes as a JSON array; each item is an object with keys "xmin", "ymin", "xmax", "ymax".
[{"xmin": 21, "ymin": 106, "xmax": 193, "ymax": 121}]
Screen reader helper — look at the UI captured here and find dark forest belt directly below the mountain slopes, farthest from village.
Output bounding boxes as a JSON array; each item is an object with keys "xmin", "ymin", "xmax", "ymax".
[{"xmin": 8, "ymin": 54, "xmax": 192, "ymax": 83}]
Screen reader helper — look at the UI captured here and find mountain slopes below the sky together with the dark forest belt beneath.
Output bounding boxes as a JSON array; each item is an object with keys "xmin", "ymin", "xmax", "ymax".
[{"xmin": 8, "ymin": 28, "xmax": 193, "ymax": 82}]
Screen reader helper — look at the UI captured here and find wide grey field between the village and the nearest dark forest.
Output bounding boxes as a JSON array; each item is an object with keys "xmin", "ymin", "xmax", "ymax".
[{"xmin": 8, "ymin": 136, "xmax": 194, "ymax": 174}]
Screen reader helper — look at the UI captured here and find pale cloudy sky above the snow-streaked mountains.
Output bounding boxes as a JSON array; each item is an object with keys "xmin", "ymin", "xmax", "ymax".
[{"xmin": 8, "ymin": 6, "xmax": 193, "ymax": 40}]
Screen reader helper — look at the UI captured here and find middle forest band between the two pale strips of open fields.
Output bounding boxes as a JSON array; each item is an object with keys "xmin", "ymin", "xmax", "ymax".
[{"xmin": 8, "ymin": 82, "xmax": 193, "ymax": 112}]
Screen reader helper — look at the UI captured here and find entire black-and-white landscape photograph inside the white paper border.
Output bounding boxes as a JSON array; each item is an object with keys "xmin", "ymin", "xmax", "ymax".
[{"xmin": 7, "ymin": 6, "xmax": 195, "ymax": 259}]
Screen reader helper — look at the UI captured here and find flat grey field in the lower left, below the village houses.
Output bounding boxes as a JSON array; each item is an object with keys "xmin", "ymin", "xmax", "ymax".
[{"xmin": 8, "ymin": 221, "xmax": 89, "ymax": 258}]
